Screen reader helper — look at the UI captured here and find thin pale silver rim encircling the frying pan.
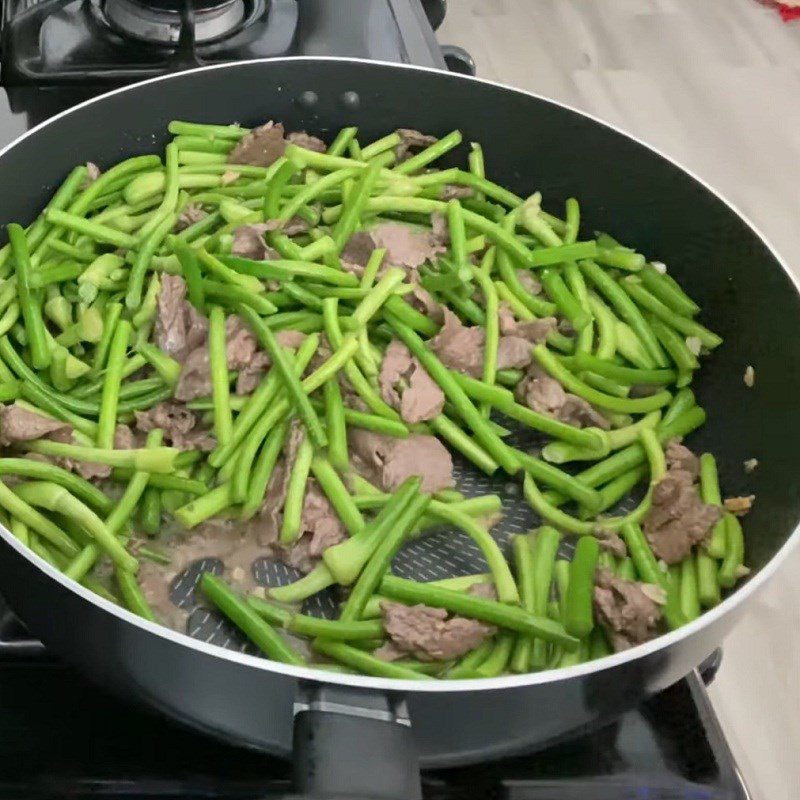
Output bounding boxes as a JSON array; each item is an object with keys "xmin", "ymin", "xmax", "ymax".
[{"xmin": 0, "ymin": 56, "xmax": 800, "ymax": 693}]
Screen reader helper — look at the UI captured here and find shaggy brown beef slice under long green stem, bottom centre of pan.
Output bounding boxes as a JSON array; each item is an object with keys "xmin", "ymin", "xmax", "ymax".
[{"xmin": 381, "ymin": 602, "xmax": 495, "ymax": 661}]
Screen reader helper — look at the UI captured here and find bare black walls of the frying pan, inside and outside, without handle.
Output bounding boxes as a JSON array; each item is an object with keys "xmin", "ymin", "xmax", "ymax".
[{"xmin": 0, "ymin": 59, "xmax": 800, "ymax": 764}]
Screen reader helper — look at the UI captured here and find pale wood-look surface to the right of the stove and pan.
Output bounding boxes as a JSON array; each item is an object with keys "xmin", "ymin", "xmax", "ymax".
[{"xmin": 439, "ymin": 0, "xmax": 800, "ymax": 800}]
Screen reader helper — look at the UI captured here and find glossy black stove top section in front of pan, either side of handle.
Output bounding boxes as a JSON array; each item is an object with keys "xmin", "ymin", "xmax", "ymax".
[{"xmin": 0, "ymin": 631, "xmax": 749, "ymax": 800}]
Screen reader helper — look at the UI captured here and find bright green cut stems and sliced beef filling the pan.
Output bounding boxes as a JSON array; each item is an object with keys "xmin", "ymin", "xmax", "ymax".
[{"xmin": 0, "ymin": 122, "xmax": 752, "ymax": 679}]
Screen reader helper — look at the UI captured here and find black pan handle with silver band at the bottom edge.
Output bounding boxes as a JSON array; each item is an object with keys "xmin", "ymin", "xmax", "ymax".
[{"xmin": 293, "ymin": 683, "xmax": 422, "ymax": 800}]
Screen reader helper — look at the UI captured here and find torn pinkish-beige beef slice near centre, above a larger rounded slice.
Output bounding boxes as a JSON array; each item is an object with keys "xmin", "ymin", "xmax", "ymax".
[{"xmin": 378, "ymin": 339, "xmax": 444, "ymax": 424}]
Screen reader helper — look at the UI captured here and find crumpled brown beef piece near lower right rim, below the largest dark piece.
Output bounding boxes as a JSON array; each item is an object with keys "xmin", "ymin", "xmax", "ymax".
[{"xmin": 594, "ymin": 569, "xmax": 661, "ymax": 651}]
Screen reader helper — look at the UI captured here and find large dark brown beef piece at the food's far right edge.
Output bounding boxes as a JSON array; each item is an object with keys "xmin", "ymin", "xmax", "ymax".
[{"xmin": 642, "ymin": 456, "xmax": 722, "ymax": 564}]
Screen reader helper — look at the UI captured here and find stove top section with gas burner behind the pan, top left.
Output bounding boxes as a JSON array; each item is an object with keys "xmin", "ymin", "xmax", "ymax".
[{"xmin": 0, "ymin": 0, "xmax": 450, "ymax": 126}]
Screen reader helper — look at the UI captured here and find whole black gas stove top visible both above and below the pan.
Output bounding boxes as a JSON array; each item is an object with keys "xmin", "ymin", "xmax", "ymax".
[{"xmin": 0, "ymin": 0, "xmax": 749, "ymax": 800}]
